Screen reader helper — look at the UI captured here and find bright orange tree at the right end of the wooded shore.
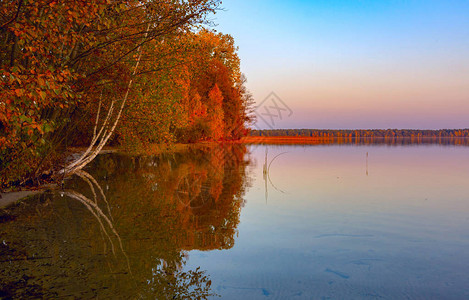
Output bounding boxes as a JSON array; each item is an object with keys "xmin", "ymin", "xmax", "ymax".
[{"xmin": 176, "ymin": 29, "xmax": 252, "ymax": 140}]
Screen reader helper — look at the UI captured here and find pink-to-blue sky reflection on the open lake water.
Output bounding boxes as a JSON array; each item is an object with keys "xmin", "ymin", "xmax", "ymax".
[{"xmin": 189, "ymin": 145, "xmax": 469, "ymax": 299}]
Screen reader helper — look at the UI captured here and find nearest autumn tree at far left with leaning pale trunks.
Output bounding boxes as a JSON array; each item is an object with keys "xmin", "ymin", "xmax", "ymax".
[{"xmin": 0, "ymin": 0, "xmax": 219, "ymax": 184}]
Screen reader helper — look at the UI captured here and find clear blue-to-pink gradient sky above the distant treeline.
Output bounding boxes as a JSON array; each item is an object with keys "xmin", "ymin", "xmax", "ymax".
[{"xmin": 213, "ymin": 0, "xmax": 469, "ymax": 129}]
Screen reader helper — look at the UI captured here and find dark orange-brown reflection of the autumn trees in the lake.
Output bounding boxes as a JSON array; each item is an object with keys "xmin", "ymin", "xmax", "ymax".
[{"xmin": 0, "ymin": 144, "xmax": 249, "ymax": 299}]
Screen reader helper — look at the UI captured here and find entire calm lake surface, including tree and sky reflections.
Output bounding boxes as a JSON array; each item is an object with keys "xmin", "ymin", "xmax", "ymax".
[{"xmin": 0, "ymin": 145, "xmax": 469, "ymax": 299}]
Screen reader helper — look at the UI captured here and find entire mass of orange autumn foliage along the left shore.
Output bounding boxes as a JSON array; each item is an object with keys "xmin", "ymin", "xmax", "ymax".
[{"xmin": 0, "ymin": 0, "xmax": 251, "ymax": 186}]
